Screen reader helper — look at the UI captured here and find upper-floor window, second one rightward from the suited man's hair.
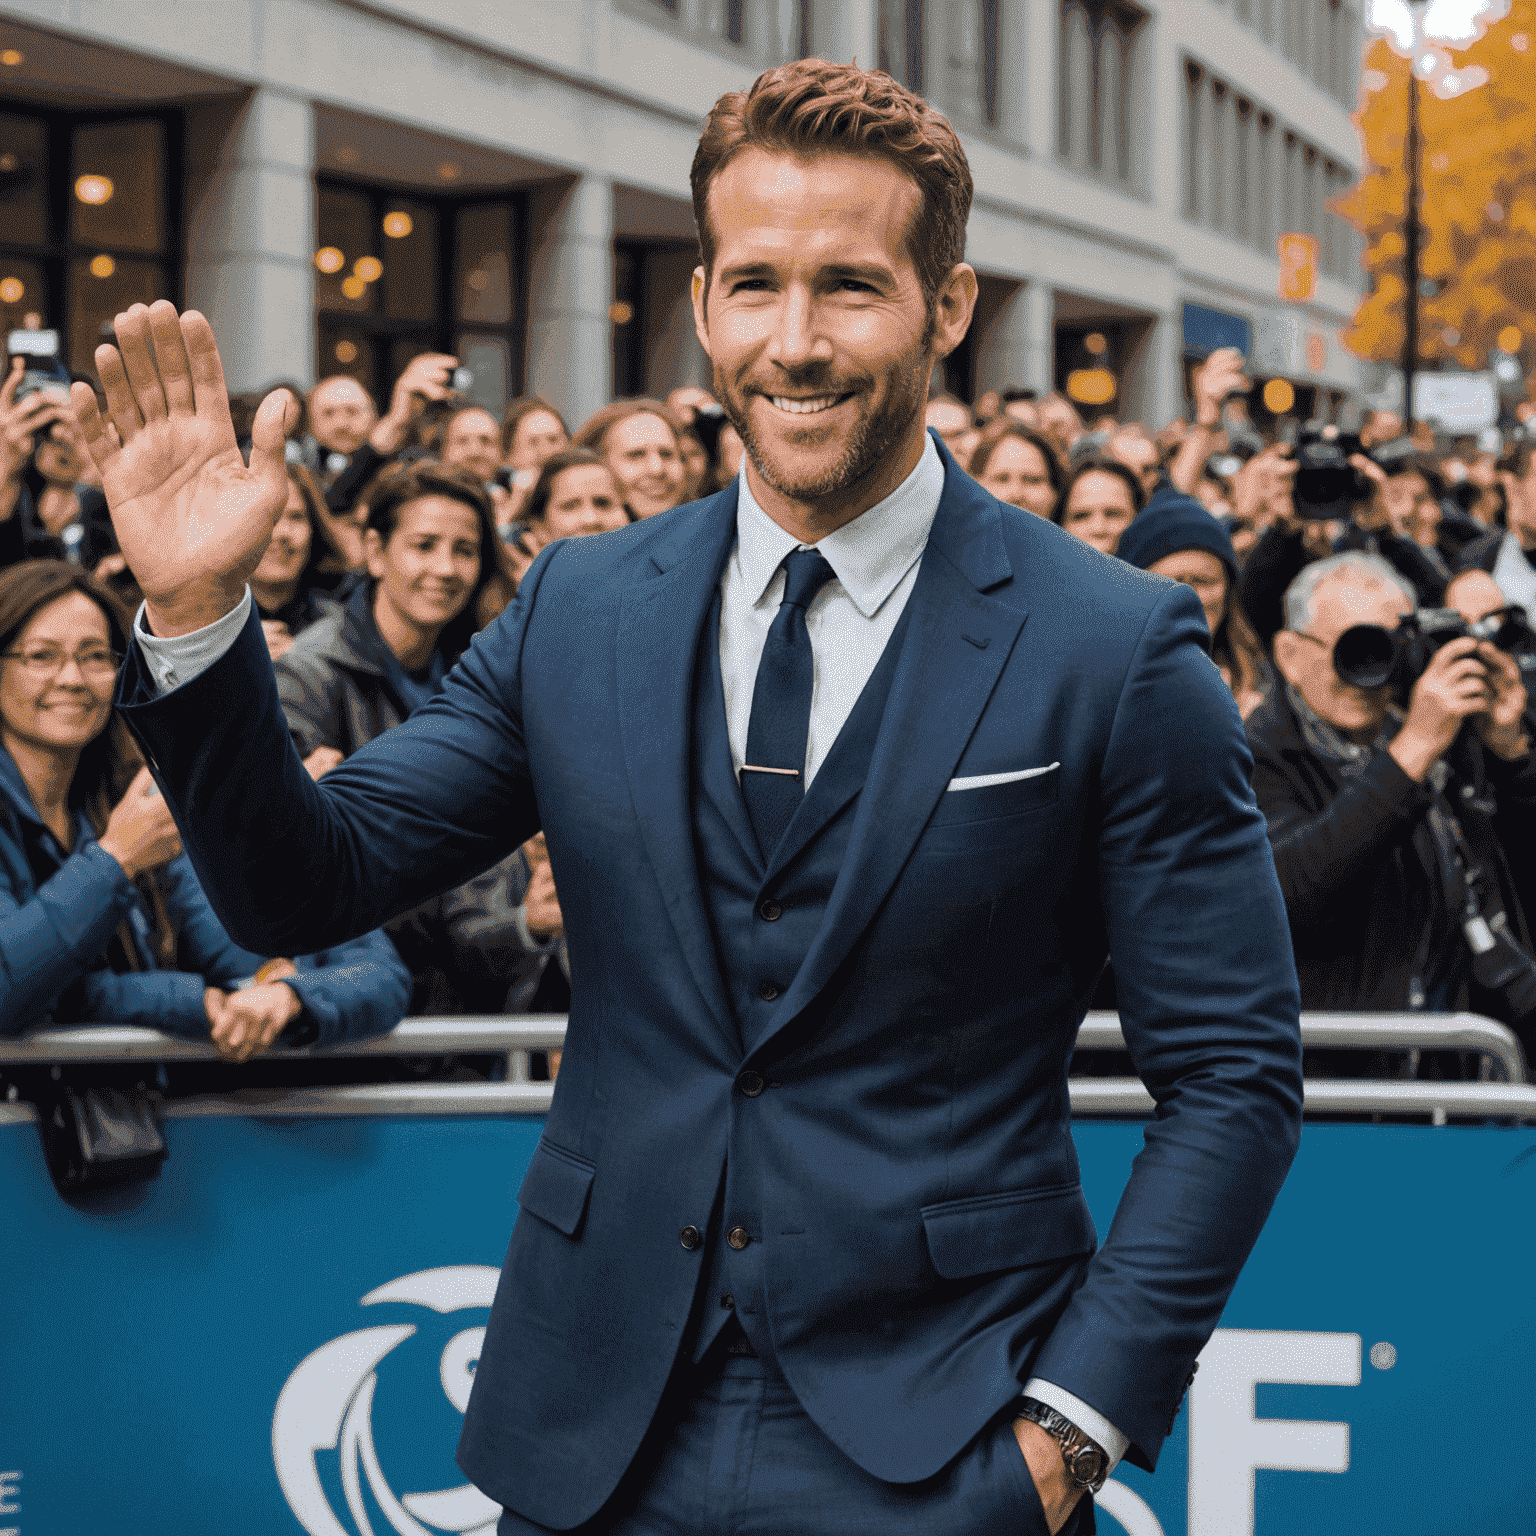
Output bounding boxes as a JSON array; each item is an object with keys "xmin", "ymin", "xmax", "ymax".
[{"xmin": 1057, "ymin": 0, "xmax": 1146, "ymax": 186}]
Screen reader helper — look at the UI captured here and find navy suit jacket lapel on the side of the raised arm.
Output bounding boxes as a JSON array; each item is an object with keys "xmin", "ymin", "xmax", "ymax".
[{"xmin": 617, "ymin": 482, "xmax": 739, "ymax": 1041}]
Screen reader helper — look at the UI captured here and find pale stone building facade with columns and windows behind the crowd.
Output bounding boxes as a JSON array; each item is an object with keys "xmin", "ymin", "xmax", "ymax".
[{"xmin": 0, "ymin": 0, "xmax": 1361, "ymax": 422}]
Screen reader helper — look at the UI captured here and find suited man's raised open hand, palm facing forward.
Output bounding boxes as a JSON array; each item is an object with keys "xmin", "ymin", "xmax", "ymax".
[{"xmin": 69, "ymin": 300, "xmax": 298, "ymax": 636}]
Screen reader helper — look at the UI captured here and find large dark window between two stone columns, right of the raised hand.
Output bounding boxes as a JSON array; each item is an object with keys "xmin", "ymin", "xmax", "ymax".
[{"xmin": 315, "ymin": 178, "xmax": 527, "ymax": 416}]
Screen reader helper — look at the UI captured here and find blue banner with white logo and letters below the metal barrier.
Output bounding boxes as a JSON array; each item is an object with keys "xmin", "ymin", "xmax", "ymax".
[{"xmin": 0, "ymin": 1115, "xmax": 1536, "ymax": 1536}]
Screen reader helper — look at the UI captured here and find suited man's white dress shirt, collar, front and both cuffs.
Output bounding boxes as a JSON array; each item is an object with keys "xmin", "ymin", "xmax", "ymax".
[{"xmin": 134, "ymin": 438, "xmax": 1129, "ymax": 1465}]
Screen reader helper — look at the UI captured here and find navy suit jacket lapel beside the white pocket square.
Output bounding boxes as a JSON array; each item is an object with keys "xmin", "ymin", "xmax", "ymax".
[{"xmin": 756, "ymin": 449, "xmax": 1026, "ymax": 1049}]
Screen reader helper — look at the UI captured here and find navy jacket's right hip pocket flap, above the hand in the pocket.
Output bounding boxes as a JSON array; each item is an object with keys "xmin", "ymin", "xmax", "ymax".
[{"xmin": 923, "ymin": 1184, "xmax": 1098, "ymax": 1279}]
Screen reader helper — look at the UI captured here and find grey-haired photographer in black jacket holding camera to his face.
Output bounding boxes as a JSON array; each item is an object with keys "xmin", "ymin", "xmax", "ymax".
[{"xmin": 1247, "ymin": 553, "xmax": 1536, "ymax": 1069}]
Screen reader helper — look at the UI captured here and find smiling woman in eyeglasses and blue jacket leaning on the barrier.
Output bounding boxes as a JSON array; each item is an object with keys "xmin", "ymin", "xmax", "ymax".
[{"xmin": 0, "ymin": 561, "xmax": 410, "ymax": 1061}]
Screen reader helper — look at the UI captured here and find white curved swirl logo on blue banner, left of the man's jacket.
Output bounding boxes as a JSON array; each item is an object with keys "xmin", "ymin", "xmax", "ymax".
[{"xmin": 272, "ymin": 1264, "xmax": 501, "ymax": 1536}]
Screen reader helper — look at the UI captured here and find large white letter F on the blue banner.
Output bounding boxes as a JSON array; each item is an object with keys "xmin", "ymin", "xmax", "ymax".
[{"xmin": 1189, "ymin": 1329, "xmax": 1359, "ymax": 1536}]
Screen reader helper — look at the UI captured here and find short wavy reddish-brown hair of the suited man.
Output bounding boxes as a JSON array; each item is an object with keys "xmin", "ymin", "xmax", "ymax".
[{"xmin": 690, "ymin": 58, "xmax": 971, "ymax": 313}]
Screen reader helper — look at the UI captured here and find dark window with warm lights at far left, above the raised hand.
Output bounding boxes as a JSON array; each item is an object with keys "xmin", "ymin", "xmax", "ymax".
[{"xmin": 0, "ymin": 103, "xmax": 183, "ymax": 378}]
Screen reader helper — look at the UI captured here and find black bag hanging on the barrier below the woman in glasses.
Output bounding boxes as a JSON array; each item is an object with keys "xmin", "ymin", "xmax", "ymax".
[{"xmin": 37, "ymin": 1081, "xmax": 166, "ymax": 1198}]
